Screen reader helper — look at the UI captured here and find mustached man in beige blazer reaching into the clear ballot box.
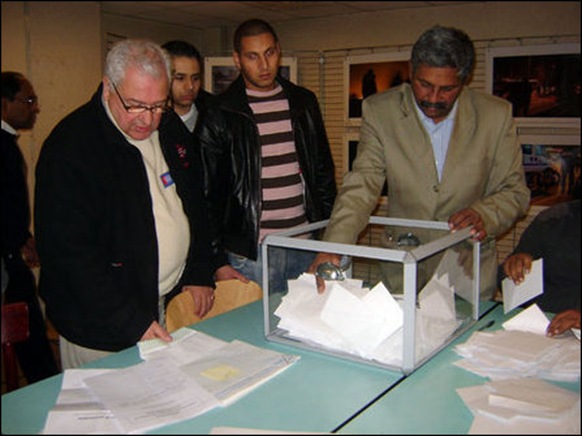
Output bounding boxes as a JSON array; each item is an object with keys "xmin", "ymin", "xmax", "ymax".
[{"xmin": 309, "ymin": 26, "xmax": 530, "ymax": 298}]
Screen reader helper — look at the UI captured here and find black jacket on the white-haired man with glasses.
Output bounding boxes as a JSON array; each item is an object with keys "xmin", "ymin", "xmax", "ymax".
[{"xmin": 35, "ymin": 87, "xmax": 219, "ymax": 351}]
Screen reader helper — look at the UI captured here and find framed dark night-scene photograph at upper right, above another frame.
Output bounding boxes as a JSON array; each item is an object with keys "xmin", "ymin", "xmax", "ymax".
[{"xmin": 485, "ymin": 43, "xmax": 580, "ymax": 128}]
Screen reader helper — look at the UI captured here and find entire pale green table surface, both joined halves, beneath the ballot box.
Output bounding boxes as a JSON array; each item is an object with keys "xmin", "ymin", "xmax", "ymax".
[{"xmin": 2, "ymin": 301, "xmax": 580, "ymax": 434}]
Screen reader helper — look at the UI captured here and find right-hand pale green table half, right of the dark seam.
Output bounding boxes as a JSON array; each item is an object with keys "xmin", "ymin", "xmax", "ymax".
[{"xmin": 337, "ymin": 305, "xmax": 580, "ymax": 434}]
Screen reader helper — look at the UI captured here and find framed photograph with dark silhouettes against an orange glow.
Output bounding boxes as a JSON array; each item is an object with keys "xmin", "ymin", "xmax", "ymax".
[{"xmin": 344, "ymin": 51, "xmax": 410, "ymax": 126}]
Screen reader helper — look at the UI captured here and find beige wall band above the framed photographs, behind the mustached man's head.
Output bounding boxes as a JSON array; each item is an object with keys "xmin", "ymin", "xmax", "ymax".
[{"xmin": 276, "ymin": 1, "xmax": 580, "ymax": 51}]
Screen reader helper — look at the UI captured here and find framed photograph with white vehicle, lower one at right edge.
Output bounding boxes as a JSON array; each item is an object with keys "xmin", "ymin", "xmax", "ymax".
[{"xmin": 520, "ymin": 135, "xmax": 580, "ymax": 206}]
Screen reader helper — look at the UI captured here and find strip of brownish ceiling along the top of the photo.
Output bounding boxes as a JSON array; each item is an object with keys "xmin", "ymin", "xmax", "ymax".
[{"xmin": 100, "ymin": 1, "xmax": 470, "ymax": 30}]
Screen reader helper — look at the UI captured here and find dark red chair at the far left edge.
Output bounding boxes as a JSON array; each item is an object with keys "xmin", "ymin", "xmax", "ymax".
[{"xmin": 2, "ymin": 303, "xmax": 30, "ymax": 392}]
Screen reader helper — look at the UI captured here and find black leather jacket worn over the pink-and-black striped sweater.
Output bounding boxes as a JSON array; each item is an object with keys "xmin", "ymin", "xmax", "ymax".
[{"xmin": 195, "ymin": 76, "xmax": 337, "ymax": 263}]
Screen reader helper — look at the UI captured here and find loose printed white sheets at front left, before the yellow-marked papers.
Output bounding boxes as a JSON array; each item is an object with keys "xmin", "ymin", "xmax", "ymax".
[{"xmin": 43, "ymin": 359, "xmax": 219, "ymax": 434}]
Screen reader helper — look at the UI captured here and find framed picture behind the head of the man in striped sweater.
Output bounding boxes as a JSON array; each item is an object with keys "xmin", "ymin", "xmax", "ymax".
[{"xmin": 204, "ymin": 56, "xmax": 297, "ymax": 94}]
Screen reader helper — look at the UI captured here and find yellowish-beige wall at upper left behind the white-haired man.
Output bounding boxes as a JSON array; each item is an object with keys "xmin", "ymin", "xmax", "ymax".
[{"xmin": 2, "ymin": 1, "xmax": 206, "ymax": 228}]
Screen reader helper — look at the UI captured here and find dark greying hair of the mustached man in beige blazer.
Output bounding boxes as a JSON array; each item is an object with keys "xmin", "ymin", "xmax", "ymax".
[{"xmin": 411, "ymin": 25, "xmax": 475, "ymax": 83}]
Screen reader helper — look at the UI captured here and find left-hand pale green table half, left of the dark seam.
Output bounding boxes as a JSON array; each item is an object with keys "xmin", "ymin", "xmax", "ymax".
[{"xmin": 2, "ymin": 301, "xmax": 404, "ymax": 434}]
